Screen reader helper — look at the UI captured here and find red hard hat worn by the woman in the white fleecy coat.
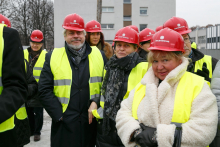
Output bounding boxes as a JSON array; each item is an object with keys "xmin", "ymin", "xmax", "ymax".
[{"xmin": 149, "ymin": 28, "xmax": 185, "ymax": 53}]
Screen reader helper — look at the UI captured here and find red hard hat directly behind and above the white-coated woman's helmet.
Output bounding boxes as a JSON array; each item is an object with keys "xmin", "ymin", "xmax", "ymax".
[{"xmin": 163, "ymin": 17, "xmax": 192, "ymax": 35}]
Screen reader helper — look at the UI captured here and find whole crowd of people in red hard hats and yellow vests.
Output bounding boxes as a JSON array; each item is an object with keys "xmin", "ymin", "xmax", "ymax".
[{"xmin": 0, "ymin": 13, "xmax": 220, "ymax": 147}]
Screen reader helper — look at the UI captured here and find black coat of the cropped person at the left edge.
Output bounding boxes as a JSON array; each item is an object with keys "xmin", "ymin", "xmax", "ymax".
[{"xmin": 0, "ymin": 27, "xmax": 28, "ymax": 147}]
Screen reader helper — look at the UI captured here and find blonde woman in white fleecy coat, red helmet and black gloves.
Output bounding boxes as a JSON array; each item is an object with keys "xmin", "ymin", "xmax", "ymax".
[{"xmin": 116, "ymin": 28, "xmax": 218, "ymax": 147}]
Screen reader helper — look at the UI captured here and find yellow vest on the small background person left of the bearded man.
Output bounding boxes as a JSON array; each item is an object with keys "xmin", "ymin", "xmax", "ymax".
[{"xmin": 24, "ymin": 49, "xmax": 47, "ymax": 82}]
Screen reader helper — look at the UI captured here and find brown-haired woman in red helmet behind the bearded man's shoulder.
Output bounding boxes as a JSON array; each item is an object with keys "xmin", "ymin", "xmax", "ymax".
[{"xmin": 86, "ymin": 20, "xmax": 113, "ymax": 60}]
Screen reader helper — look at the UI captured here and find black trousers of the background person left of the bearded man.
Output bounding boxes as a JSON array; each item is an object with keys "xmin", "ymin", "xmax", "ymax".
[{"xmin": 26, "ymin": 107, "xmax": 43, "ymax": 135}]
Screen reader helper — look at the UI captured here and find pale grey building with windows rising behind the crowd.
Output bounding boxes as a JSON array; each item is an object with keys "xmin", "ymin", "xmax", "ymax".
[{"xmin": 54, "ymin": 0, "xmax": 176, "ymax": 47}]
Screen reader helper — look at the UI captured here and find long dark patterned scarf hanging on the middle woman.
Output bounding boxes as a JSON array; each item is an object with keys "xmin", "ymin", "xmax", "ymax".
[{"xmin": 101, "ymin": 52, "xmax": 137, "ymax": 135}]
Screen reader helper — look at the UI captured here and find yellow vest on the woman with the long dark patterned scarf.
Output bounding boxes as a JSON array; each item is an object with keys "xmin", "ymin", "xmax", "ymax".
[{"xmin": 92, "ymin": 62, "xmax": 148, "ymax": 119}]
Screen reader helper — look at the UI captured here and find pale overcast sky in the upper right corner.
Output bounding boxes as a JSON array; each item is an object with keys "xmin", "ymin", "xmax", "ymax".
[{"xmin": 176, "ymin": 0, "xmax": 220, "ymax": 27}]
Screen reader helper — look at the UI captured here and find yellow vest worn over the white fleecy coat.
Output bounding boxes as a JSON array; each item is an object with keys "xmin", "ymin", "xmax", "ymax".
[{"xmin": 132, "ymin": 72, "xmax": 204, "ymax": 123}]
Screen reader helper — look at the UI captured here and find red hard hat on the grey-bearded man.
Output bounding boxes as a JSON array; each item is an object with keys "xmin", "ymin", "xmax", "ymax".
[{"xmin": 62, "ymin": 13, "xmax": 84, "ymax": 31}]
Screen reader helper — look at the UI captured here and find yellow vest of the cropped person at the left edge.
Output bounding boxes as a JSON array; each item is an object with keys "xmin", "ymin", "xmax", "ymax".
[{"xmin": 0, "ymin": 24, "xmax": 15, "ymax": 133}]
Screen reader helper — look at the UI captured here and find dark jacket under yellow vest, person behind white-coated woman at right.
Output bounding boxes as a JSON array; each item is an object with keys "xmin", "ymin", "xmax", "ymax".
[{"xmin": 187, "ymin": 48, "xmax": 218, "ymax": 73}]
